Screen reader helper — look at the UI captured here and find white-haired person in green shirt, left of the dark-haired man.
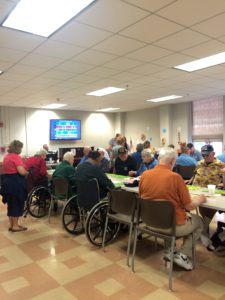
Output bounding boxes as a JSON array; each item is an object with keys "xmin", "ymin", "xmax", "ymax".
[{"xmin": 52, "ymin": 152, "xmax": 76, "ymax": 197}]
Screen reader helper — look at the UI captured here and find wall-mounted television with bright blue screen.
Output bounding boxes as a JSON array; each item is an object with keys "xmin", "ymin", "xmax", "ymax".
[{"xmin": 50, "ymin": 119, "xmax": 81, "ymax": 140}]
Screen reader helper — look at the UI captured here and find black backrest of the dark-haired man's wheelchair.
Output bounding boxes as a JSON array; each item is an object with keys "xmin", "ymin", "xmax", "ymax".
[{"xmin": 76, "ymin": 178, "xmax": 100, "ymax": 210}]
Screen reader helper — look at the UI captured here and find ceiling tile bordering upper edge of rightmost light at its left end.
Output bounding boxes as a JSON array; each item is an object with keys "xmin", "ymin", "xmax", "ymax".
[{"xmin": 154, "ymin": 53, "xmax": 194, "ymax": 68}]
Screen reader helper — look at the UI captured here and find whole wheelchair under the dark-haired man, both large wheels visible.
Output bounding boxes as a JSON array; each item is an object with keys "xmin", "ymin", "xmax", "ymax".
[{"xmin": 62, "ymin": 179, "xmax": 120, "ymax": 247}]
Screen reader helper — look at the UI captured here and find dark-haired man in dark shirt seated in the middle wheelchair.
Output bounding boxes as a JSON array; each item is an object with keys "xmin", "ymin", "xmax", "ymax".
[{"xmin": 76, "ymin": 151, "xmax": 114, "ymax": 198}]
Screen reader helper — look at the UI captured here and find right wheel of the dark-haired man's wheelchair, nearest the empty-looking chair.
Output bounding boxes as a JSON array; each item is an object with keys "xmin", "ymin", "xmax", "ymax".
[{"xmin": 85, "ymin": 201, "xmax": 120, "ymax": 247}]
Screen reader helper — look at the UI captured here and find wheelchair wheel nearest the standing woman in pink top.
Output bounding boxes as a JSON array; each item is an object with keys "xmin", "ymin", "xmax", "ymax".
[{"xmin": 27, "ymin": 186, "xmax": 51, "ymax": 218}]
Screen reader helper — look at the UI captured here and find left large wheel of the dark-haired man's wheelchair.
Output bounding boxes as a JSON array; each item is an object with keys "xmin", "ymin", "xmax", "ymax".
[{"xmin": 62, "ymin": 195, "xmax": 84, "ymax": 234}]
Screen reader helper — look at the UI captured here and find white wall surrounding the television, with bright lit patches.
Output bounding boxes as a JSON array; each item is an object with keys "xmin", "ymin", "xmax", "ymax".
[{"xmin": 0, "ymin": 107, "xmax": 115, "ymax": 155}]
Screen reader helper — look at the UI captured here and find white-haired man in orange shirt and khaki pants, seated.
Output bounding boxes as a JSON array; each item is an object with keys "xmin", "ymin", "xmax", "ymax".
[{"xmin": 139, "ymin": 148, "xmax": 206, "ymax": 270}]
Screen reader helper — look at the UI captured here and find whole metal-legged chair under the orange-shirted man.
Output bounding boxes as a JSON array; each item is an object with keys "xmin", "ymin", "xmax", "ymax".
[{"xmin": 132, "ymin": 198, "xmax": 195, "ymax": 290}]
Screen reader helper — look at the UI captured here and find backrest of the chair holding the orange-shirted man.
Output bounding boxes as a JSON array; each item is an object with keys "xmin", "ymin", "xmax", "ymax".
[{"xmin": 138, "ymin": 198, "xmax": 176, "ymax": 236}]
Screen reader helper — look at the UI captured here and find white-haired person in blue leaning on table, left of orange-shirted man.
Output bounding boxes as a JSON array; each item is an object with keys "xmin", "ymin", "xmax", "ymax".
[{"xmin": 129, "ymin": 149, "xmax": 159, "ymax": 176}]
